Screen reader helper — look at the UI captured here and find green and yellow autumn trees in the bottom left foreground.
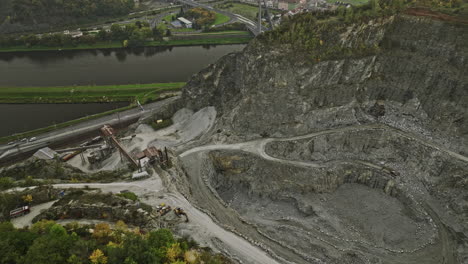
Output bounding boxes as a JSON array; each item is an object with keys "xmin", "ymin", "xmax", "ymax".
[{"xmin": 0, "ymin": 220, "xmax": 230, "ymax": 264}]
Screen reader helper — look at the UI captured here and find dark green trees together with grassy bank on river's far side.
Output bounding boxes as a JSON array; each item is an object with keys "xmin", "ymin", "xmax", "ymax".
[{"xmin": 0, "ymin": 19, "xmax": 252, "ymax": 52}]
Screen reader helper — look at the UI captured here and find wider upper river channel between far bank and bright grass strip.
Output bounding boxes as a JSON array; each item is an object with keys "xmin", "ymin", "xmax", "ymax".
[{"xmin": 0, "ymin": 45, "xmax": 245, "ymax": 87}]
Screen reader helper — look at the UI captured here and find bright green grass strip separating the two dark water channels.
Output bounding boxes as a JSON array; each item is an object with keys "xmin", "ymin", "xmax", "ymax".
[{"xmin": 0, "ymin": 82, "xmax": 185, "ymax": 103}]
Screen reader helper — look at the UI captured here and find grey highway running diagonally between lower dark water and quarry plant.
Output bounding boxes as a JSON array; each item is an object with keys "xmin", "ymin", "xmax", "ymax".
[{"xmin": 0, "ymin": 96, "xmax": 180, "ymax": 161}]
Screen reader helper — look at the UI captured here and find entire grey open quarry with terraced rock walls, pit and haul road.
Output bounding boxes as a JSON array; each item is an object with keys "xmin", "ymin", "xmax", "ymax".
[{"xmin": 180, "ymin": 13, "xmax": 468, "ymax": 264}]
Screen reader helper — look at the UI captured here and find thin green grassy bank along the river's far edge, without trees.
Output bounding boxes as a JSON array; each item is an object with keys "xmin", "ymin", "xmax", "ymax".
[{"xmin": 0, "ymin": 34, "xmax": 253, "ymax": 53}]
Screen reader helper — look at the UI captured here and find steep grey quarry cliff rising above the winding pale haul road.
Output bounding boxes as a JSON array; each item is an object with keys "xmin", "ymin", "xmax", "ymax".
[{"xmin": 183, "ymin": 13, "xmax": 468, "ymax": 153}]
